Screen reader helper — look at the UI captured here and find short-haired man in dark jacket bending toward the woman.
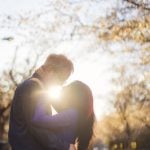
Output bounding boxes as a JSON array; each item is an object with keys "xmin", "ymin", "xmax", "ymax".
[{"xmin": 8, "ymin": 54, "xmax": 74, "ymax": 150}]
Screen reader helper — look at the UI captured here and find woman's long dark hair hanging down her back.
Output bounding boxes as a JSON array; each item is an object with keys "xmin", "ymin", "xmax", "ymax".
[{"xmin": 64, "ymin": 81, "xmax": 94, "ymax": 150}]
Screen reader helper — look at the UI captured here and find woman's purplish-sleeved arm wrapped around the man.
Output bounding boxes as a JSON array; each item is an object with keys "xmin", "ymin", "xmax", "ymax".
[{"xmin": 32, "ymin": 99, "xmax": 78, "ymax": 129}]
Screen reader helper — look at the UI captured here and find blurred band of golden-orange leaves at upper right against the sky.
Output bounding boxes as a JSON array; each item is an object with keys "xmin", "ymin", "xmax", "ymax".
[{"xmin": 99, "ymin": 16, "xmax": 150, "ymax": 43}]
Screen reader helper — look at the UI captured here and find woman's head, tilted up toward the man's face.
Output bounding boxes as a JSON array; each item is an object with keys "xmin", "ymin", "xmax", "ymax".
[{"xmin": 62, "ymin": 81, "xmax": 93, "ymax": 116}]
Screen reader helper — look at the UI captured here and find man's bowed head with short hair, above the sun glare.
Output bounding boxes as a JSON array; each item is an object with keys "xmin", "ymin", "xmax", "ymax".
[{"xmin": 37, "ymin": 54, "xmax": 74, "ymax": 84}]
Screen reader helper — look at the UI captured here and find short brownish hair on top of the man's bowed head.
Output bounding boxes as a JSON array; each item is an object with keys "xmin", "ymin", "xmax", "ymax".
[{"xmin": 42, "ymin": 54, "xmax": 74, "ymax": 74}]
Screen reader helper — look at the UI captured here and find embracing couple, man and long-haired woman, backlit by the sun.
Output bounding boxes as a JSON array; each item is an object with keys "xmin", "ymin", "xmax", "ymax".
[{"xmin": 8, "ymin": 54, "xmax": 94, "ymax": 150}]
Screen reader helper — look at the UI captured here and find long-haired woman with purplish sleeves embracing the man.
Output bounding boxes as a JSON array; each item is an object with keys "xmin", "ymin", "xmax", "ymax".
[{"xmin": 32, "ymin": 81, "xmax": 94, "ymax": 150}]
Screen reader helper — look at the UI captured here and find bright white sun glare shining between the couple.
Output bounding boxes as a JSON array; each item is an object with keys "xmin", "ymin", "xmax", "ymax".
[{"xmin": 48, "ymin": 85, "xmax": 62, "ymax": 100}]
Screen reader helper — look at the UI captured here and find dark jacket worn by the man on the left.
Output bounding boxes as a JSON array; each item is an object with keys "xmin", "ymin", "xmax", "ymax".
[{"xmin": 8, "ymin": 74, "xmax": 69, "ymax": 150}]
